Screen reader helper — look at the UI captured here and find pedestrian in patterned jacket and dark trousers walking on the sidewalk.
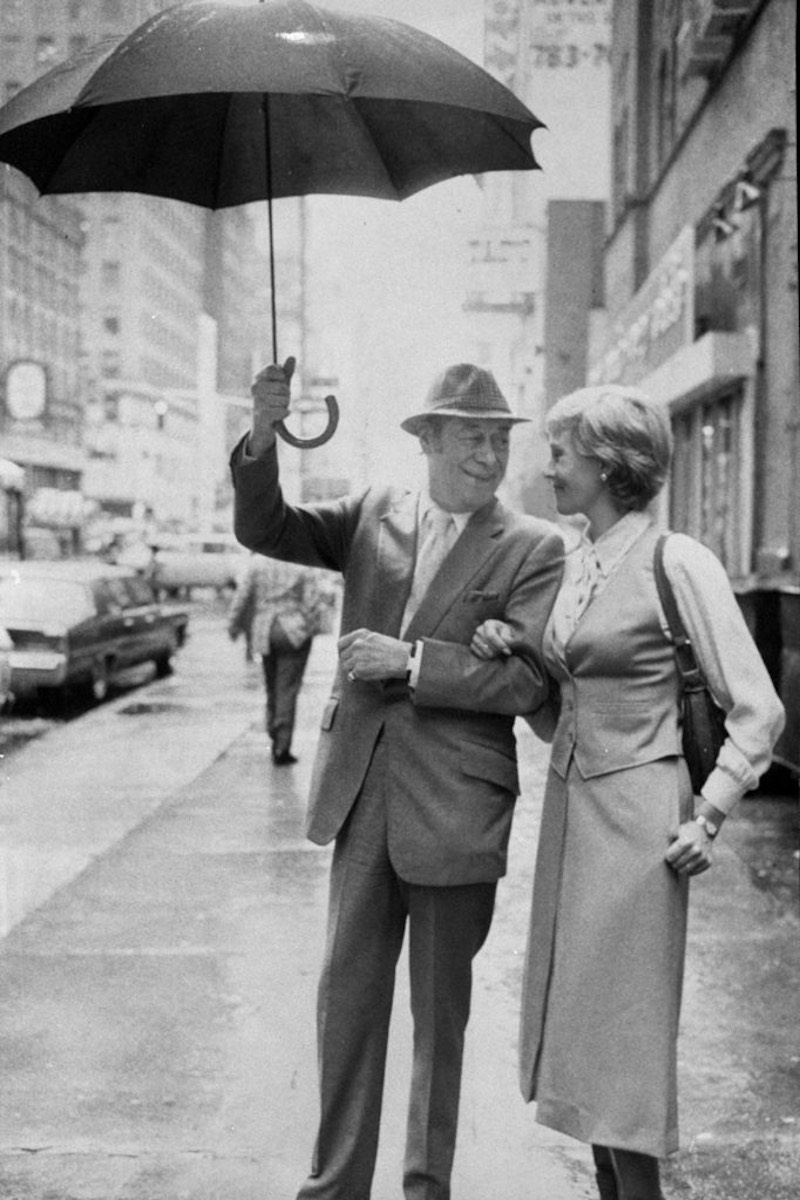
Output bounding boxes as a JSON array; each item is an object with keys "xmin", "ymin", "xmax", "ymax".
[{"xmin": 228, "ymin": 554, "xmax": 324, "ymax": 767}]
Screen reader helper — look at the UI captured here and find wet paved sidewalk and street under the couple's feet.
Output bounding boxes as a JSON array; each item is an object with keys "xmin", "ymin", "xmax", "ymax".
[{"xmin": 0, "ymin": 610, "xmax": 800, "ymax": 1200}]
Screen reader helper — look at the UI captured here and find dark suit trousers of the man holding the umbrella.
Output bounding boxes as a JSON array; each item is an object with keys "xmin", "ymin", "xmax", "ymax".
[{"xmin": 297, "ymin": 740, "xmax": 497, "ymax": 1200}]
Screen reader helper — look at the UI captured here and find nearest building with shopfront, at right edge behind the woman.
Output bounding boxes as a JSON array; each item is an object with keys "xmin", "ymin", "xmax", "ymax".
[{"xmin": 589, "ymin": 0, "xmax": 800, "ymax": 770}]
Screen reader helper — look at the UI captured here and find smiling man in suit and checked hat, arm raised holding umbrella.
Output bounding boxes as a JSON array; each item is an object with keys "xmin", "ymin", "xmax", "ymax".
[{"xmin": 231, "ymin": 359, "xmax": 564, "ymax": 1200}]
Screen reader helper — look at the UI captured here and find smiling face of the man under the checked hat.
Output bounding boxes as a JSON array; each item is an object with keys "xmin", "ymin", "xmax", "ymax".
[{"xmin": 420, "ymin": 416, "xmax": 511, "ymax": 512}]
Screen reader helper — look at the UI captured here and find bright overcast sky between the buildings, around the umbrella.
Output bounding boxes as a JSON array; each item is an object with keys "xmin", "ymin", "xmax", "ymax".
[{"xmin": 278, "ymin": 0, "xmax": 496, "ymax": 468}]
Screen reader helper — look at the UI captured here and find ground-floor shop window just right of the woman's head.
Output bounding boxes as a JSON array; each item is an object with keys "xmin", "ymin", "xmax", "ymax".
[{"xmin": 670, "ymin": 390, "xmax": 744, "ymax": 576}]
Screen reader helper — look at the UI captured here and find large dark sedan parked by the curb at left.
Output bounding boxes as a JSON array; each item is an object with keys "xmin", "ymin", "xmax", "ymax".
[{"xmin": 0, "ymin": 560, "xmax": 188, "ymax": 702}]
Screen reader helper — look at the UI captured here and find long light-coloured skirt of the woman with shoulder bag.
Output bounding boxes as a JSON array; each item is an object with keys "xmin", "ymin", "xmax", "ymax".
[{"xmin": 521, "ymin": 758, "xmax": 692, "ymax": 1157}]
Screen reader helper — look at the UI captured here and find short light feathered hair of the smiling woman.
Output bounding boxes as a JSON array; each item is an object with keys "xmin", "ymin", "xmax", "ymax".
[{"xmin": 545, "ymin": 384, "xmax": 673, "ymax": 510}]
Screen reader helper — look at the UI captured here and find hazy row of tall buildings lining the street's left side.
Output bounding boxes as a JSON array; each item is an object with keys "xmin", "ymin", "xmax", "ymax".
[{"xmin": 0, "ymin": 0, "xmax": 269, "ymax": 552}]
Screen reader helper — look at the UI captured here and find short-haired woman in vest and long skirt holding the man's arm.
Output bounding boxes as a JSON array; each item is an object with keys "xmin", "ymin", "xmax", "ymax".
[{"xmin": 474, "ymin": 386, "xmax": 783, "ymax": 1200}]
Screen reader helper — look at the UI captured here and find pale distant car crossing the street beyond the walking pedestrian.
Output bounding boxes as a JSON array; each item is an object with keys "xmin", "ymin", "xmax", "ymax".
[{"xmin": 116, "ymin": 533, "xmax": 247, "ymax": 596}]
